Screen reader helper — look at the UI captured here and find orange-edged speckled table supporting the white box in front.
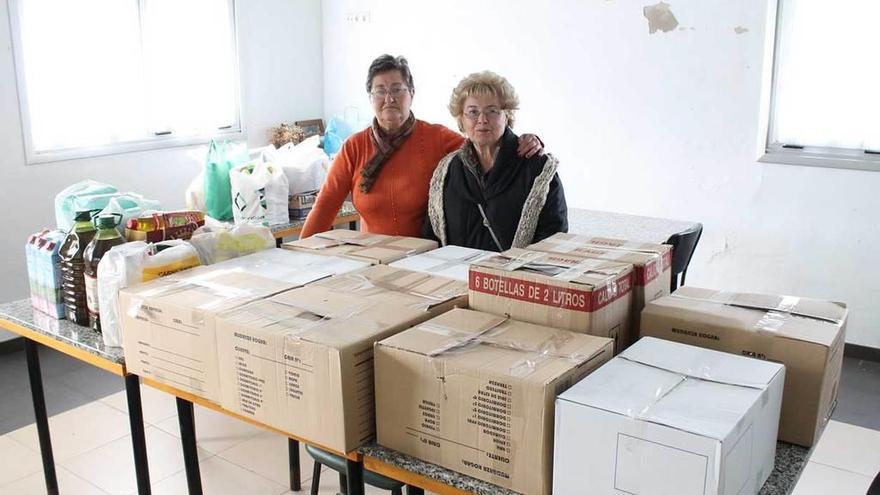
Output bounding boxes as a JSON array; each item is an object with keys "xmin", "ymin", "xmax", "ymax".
[{"xmin": 358, "ymin": 442, "xmax": 810, "ymax": 495}]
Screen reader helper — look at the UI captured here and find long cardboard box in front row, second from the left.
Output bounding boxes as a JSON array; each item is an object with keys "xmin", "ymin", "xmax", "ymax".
[{"xmin": 217, "ymin": 265, "xmax": 467, "ymax": 452}]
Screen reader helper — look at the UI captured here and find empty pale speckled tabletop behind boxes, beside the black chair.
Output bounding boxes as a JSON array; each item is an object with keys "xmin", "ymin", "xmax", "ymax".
[{"xmin": 568, "ymin": 208, "xmax": 698, "ymax": 243}]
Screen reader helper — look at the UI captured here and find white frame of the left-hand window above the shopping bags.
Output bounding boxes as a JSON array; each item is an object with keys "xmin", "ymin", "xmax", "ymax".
[{"xmin": 8, "ymin": 0, "xmax": 247, "ymax": 165}]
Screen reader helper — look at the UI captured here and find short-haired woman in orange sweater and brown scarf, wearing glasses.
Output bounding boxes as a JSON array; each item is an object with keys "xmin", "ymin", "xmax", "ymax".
[{"xmin": 300, "ymin": 55, "xmax": 542, "ymax": 238}]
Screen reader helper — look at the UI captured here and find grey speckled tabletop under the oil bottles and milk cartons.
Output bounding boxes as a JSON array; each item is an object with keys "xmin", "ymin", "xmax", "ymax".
[{"xmin": 0, "ymin": 299, "xmax": 125, "ymax": 364}]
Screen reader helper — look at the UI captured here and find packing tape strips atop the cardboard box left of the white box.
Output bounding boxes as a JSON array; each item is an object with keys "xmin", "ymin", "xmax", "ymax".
[{"xmin": 414, "ymin": 316, "xmax": 592, "ymax": 378}]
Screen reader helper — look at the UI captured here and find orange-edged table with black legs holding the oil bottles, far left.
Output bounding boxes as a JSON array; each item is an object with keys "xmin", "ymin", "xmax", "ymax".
[{"xmin": 0, "ymin": 299, "xmax": 150, "ymax": 494}]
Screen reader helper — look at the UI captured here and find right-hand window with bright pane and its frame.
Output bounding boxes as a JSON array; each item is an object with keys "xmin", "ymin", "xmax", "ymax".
[{"xmin": 760, "ymin": 0, "xmax": 880, "ymax": 170}]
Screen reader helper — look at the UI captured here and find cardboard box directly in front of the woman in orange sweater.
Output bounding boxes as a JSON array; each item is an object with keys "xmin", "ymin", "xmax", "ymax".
[{"xmin": 281, "ymin": 229, "xmax": 437, "ymax": 265}]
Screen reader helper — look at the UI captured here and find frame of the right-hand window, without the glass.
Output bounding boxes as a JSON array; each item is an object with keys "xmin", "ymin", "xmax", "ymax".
[{"xmin": 757, "ymin": 0, "xmax": 880, "ymax": 172}]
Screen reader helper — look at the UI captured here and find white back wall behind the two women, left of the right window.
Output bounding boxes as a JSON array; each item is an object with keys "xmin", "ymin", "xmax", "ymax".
[{"xmin": 323, "ymin": 0, "xmax": 880, "ymax": 347}]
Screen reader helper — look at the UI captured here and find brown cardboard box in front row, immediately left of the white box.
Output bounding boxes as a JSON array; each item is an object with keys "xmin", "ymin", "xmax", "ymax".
[{"xmin": 375, "ymin": 309, "xmax": 612, "ymax": 495}]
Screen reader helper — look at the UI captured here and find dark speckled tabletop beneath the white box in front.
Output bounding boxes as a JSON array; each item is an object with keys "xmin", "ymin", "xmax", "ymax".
[{"xmin": 358, "ymin": 442, "xmax": 810, "ymax": 495}]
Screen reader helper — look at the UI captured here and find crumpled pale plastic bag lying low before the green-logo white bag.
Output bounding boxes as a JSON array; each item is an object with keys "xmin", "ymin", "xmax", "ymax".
[{"xmin": 189, "ymin": 224, "xmax": 275, "ymax": 265}]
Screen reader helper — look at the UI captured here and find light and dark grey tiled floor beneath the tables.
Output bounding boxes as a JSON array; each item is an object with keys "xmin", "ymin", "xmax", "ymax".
[{"xmin": 0, "ymin": 349, "xmax": 880, "ymax": 495}]
